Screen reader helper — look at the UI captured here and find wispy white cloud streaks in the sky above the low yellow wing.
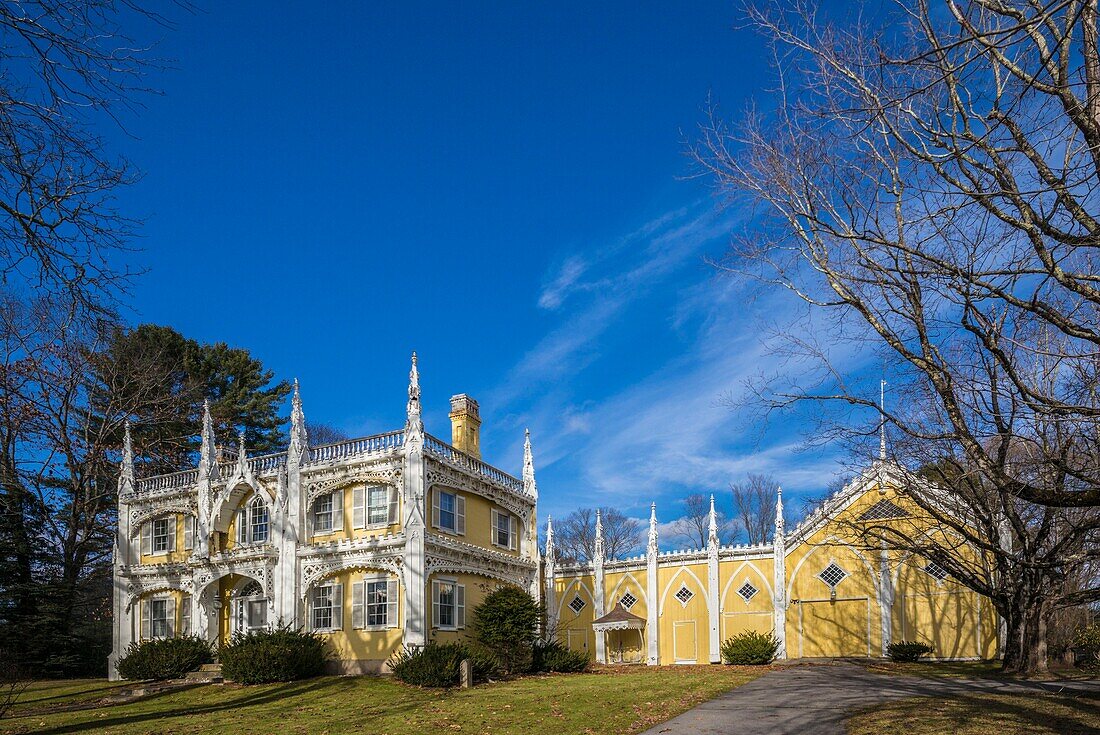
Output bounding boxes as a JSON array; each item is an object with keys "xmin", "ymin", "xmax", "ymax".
[{"xmin": 487, "ymin": 198, "xmax": 860, "ymax": 518}]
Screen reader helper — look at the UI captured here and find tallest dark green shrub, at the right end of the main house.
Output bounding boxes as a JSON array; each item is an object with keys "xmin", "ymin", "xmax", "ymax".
[{"xmin": 472, "ymin": 585, "xmax": 542, "ymax": 673}]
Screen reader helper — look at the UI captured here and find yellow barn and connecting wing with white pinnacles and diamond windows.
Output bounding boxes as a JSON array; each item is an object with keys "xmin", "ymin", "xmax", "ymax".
[{"xmin": 543, "ymin": 461, "xmax": 998, "ymax": 665}]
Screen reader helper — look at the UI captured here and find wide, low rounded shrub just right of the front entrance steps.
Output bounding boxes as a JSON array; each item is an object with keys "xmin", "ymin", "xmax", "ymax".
[{"xmin": 218, "ymin": 627, "xmax": 326, "ymax": 684}]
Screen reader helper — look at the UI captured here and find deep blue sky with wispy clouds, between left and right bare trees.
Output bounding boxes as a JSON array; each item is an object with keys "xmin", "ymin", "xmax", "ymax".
[{"xmin": 111, "ymin": 2, "xmax": 858, "ymax": 539}]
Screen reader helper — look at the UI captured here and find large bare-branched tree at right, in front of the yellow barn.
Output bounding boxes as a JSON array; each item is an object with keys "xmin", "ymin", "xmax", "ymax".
[{"xmin": 694, "ymin": 0, "xmax": 1100, "ymax": 672}]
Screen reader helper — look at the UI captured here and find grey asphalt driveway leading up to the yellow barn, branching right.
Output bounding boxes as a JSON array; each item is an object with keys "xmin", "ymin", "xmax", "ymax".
[{"xmin": 642, "ymin": 663, "xmax": 1098, "ymax": 735}]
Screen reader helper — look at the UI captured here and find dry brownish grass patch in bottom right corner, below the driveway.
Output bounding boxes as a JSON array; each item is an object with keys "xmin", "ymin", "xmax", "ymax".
[{"xmin": 848, "ymin": 693, "xmax": 1100, "ymax": 735}]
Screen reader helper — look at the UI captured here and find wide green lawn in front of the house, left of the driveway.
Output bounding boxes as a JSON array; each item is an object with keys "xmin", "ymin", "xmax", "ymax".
[{"xmin": 0, "ymin": 666, "xmax": 768, "ymax": 735}]
